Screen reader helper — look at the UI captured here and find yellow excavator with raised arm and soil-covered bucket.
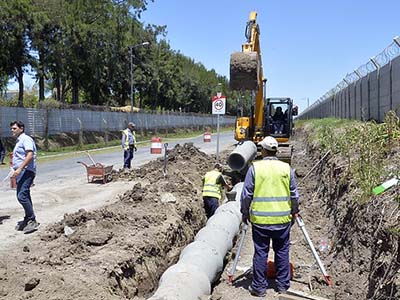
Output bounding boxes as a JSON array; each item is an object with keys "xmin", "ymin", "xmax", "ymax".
[{"xmin": 229, "ymin": 11, "xmax": 298, "ymax": 163}]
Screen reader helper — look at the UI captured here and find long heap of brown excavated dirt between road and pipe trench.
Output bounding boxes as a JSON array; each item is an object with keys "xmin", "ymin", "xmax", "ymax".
[{"xmin": 0, "ymin": 144, "xmax": 222, "ymax": 300}]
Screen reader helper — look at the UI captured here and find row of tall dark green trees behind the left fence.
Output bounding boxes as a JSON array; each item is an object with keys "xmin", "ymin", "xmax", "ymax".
[{"xmin": 0, "ymin": 0, "xmax": 225, "ymax": 112}]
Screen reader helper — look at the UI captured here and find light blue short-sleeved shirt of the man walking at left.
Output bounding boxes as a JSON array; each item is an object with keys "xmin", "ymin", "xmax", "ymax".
[{"xmin": 13, "ymin": 132, "xmax": 36, "ymax": 173}]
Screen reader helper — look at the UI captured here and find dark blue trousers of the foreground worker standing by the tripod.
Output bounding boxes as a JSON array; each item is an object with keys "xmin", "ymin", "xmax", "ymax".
[{"xmin": 251, "ymin": 225, "xmax": 291, "ymax": 293}]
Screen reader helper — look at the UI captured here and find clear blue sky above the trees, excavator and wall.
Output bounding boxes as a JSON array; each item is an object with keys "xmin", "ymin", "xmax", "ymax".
[{"xmin": 141, "ymin": 0, "xmax": 400, "ymax": 110}]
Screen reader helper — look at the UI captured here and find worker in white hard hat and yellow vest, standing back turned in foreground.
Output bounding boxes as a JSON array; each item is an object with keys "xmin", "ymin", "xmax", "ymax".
[{"xmin": 240, "ymin": 136, "xmax": 299, "ymax": 297}]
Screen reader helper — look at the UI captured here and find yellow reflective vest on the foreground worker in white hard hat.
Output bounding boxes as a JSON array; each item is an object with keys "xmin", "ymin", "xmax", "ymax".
[{"xmin": 250, "ymin": 160, "xmax": 292, "ymax": 225}]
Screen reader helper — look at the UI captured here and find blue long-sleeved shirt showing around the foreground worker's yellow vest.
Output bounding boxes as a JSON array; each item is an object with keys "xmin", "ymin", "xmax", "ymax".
[{"xmin": 240, "ymin": 156, "xmax": 299, "ymax": 230}]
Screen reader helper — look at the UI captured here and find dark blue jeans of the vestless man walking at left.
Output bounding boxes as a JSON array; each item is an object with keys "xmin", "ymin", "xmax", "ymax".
[{"xmin": 17, "ymin": 170, "xmax": 36, "ymax": 221}]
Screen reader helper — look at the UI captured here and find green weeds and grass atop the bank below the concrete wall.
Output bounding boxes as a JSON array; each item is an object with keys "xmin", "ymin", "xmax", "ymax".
[{"xmin": 299, "ymin": 111, "xmax": 400, "ymax": 201}]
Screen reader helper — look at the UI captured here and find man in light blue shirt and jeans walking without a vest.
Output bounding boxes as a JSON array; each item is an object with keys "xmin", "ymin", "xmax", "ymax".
[{"xmin": 10, "ymin": 121, "xmax": 40, "ymax": 233}]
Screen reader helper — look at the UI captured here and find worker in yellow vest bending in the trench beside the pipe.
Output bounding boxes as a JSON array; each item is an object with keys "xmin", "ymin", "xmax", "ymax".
[{"xmin": 203, "ymin": 163, "xmax": 231, "ymax": 219}]
